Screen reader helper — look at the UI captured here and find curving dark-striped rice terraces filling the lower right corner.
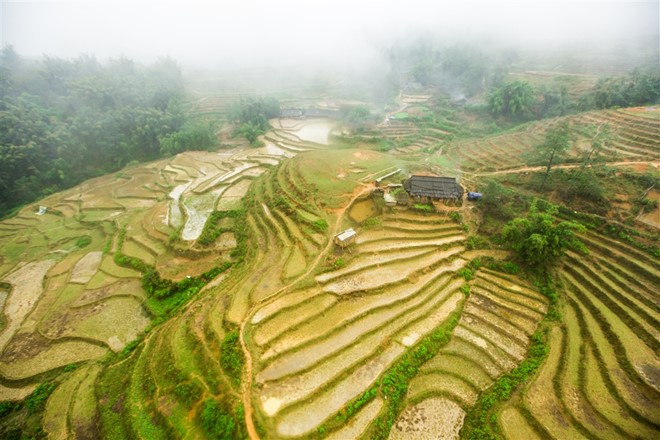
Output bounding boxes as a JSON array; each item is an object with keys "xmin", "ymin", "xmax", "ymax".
[{"xmin": 500, "ymin": 233, "xmax": 660, "ymax": 438}]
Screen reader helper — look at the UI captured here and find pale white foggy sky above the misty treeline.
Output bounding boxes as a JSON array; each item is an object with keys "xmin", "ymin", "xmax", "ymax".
[{"xmin": 0, "ymin": 0, "xmax": 660, "ymax": 68}]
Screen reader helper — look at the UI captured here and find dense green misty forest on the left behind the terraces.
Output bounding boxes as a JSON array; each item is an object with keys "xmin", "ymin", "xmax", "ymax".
[{"xmin": 0, "ymin": 47, "xmax": 216, "ymax": 217}]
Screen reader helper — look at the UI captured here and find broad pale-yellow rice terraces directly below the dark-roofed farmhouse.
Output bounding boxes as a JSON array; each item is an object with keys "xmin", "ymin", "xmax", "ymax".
[{"xmin": 246, "ymin": 211, "xmax": 466, "ymax": 437}]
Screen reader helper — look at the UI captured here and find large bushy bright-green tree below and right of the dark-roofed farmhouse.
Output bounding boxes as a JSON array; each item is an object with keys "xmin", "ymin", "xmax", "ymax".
[{"xmin": 502, "ymin": 199, "xmax": 587, "ymax": 268}]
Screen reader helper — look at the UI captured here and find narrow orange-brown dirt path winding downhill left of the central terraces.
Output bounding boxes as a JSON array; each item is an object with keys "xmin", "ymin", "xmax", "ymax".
[{"xmin": 239, "ymin": 184, "xmax": 373, "ymax": 440}]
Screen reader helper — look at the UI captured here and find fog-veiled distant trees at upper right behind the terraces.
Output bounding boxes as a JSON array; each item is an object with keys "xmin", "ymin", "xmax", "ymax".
[{"xmin": 386, "ymin": 41, "xmax": 660, "ymax": 120}]
